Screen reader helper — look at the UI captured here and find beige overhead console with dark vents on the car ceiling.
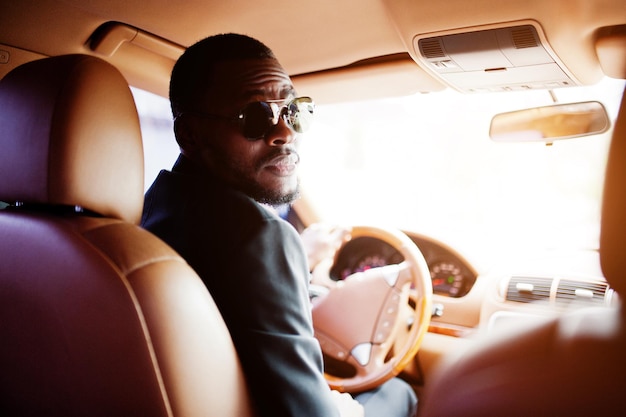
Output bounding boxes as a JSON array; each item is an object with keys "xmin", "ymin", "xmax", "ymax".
[{"xmin": 413, "ymin": 21, "xmax": 579, "ymax": 93}]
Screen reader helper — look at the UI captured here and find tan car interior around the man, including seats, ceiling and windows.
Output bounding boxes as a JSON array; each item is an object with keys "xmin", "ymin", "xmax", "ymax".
[{"xmin": 0, "ymin": 0, "xmax": 626, "ymax": 417}]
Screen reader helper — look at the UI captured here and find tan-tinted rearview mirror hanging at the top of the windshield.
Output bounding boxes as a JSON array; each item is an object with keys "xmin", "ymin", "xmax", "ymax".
[{"xmin": 489, "ymin": 101, "xmax": 611, "ymax": 143}]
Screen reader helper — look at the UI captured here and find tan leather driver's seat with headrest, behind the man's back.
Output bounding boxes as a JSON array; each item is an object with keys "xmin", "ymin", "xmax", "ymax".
[{"xmin": 0, "ymin": 55, "xmax": 250, "ymax": 417}]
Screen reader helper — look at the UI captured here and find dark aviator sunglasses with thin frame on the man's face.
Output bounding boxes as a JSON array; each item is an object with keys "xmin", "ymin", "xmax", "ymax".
[{"xmin": 185, "ymin": 97, "xmax": 315, "ymax": 141}]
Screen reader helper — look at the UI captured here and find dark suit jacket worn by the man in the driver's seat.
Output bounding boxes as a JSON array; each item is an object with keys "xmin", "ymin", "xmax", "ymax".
[{"xmin": 142, "ymin": 155, "xmax": 338, "ymax": 417}]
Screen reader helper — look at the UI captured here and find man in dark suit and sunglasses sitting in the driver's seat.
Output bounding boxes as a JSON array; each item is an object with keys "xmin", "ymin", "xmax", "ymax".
[{"xmin": 142, "ymin": 34, "xmax": 416, "ymax": 417}]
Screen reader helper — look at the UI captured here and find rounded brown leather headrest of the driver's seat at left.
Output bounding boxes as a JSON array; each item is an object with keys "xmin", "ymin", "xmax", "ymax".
[{"xmin": 0, "ymin": 55, "xmax": 144, "ymax": 223}]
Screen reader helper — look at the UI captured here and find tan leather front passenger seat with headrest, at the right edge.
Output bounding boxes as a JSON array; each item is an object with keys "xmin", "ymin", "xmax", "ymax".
[{"xmin": 420, "ymin": 88, "xmax": 626, "ymax": 417}]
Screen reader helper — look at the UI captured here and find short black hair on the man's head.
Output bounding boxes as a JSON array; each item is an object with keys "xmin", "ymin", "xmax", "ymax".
[{"xmin": 169, "ymin": 33, "xmax": 276, "ymax": 118}]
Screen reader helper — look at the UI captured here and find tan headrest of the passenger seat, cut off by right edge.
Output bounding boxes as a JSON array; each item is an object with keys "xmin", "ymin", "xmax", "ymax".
[{"xmin": 600, "ymin": 88, "xmax": 626, "ymax": 297}]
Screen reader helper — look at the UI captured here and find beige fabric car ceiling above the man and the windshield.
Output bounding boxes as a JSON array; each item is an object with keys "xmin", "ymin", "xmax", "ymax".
[{"xmin": 0, "ymin": 0, "xmax": 626, "ymax": 101}]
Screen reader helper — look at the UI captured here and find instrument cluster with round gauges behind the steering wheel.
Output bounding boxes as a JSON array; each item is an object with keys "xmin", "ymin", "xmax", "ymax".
[{"xmin": 330, "ymin": 233, "xmax": 478, "ymax": 298}]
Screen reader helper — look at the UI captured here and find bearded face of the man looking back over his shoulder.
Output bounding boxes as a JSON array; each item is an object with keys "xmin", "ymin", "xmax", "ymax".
[{"xmin": 184, "ymin": 59, "xmax": 299, "ymax": 204}]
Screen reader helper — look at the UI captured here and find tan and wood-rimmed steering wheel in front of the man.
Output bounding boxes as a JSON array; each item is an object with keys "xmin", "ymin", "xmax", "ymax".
[{"xmin": 312, "ymin": 226, "xmax": 433, "ymax": 393}]
